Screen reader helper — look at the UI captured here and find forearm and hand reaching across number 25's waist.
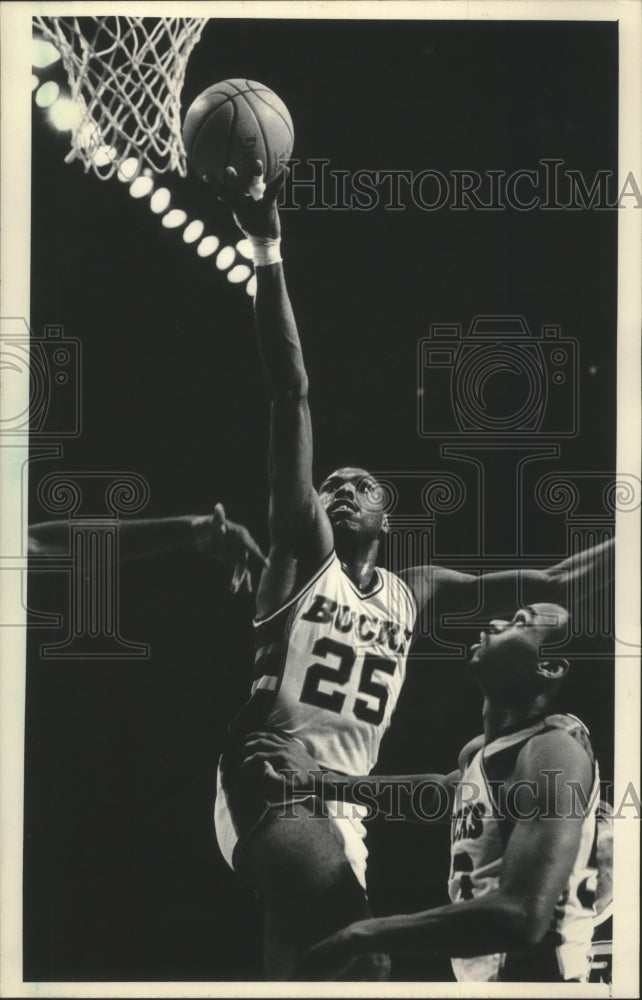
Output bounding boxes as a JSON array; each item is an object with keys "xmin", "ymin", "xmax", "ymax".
[{"xmin": 243, "ymin": 732, "xmax": 461, "ymax": 823}]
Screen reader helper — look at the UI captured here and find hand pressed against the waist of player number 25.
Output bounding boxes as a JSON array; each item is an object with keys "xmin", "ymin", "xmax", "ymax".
[{"xmin": 242, "ymin": 732, "xmax": 321, "ymax": 800}]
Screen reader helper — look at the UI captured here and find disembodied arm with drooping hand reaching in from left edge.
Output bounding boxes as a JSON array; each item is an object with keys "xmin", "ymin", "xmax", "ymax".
[{"xmin": 28, "ymin": 503, "xmax": 267, "ymax": 593}]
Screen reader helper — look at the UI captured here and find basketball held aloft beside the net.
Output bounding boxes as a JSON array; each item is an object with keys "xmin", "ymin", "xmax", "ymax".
[{"xmin": 183, "ymin": 80, "xmax": 294, "ymax": 187}]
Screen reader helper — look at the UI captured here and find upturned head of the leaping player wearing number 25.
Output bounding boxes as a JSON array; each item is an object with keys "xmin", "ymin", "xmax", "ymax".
[{"xmin": 319, "ymin": 466, "xmax": 388, "ymax": 540}]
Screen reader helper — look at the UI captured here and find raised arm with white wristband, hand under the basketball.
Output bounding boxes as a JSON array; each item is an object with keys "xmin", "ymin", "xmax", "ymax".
[{"xmin": 223, "ymin": 160, "xmax": 333, "ymax": 614}]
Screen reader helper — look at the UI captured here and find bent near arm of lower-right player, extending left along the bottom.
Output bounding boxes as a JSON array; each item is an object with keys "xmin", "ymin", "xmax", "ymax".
[{"xmin": 292, "ymin": 732, "xmax": 593, "ymax": 979}]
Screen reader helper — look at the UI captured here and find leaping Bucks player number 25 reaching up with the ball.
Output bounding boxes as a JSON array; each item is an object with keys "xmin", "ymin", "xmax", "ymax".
[{"xmin": 215, "ymin": 168, "xmax": 609, "ymax": 980}]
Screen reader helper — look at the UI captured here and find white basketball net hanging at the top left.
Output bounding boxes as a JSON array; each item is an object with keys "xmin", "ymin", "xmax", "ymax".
[{"xmin": 34, "ymin": 17, "xmax": 206, "ymax": 180}]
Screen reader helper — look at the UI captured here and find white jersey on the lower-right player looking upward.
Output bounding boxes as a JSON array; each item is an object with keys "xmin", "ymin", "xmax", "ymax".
[{"xmin": 448, "ymin": 715, "xmax": 599, "ymax": 982}]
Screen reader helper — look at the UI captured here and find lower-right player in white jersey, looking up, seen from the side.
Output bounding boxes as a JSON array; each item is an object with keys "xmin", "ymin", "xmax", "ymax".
[{"xmin": 246, "ymin": 604, "xmax": 599, "ymax": 982}]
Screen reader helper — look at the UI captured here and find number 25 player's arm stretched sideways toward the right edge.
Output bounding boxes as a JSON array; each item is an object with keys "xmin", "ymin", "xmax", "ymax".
[{"xmin": 399, "ymin": 538, "xmax": 615, "ymax": 614}]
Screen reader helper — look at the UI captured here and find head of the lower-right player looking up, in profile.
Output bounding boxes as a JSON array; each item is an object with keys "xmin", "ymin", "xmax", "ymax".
[{"xmin": 470, "ymin": 604, "xmax": 568, "ymax": 704}]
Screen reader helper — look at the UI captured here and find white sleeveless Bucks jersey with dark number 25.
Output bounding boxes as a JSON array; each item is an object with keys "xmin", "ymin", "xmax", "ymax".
[{"xmin": 241, "ymin": 552, "xmax": 416, "ymax": 774}]
